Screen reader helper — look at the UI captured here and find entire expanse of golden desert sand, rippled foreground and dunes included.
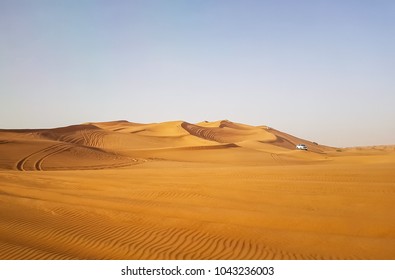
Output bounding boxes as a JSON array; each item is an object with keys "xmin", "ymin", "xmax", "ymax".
[{"xmin": 0, "ymin": 121, "xmax": 395, "ymax": 259}]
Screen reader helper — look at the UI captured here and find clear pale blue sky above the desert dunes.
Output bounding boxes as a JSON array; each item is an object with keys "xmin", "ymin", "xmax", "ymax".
[{"xmin": 0, "ymin": 0, "xmax": 395, "ymax": 147}]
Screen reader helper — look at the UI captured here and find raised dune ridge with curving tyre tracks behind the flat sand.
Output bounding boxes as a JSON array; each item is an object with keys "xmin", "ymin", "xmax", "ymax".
[{"xmin": 0, "ymin": 121, "xmax": 334, "ymax": 171}]
